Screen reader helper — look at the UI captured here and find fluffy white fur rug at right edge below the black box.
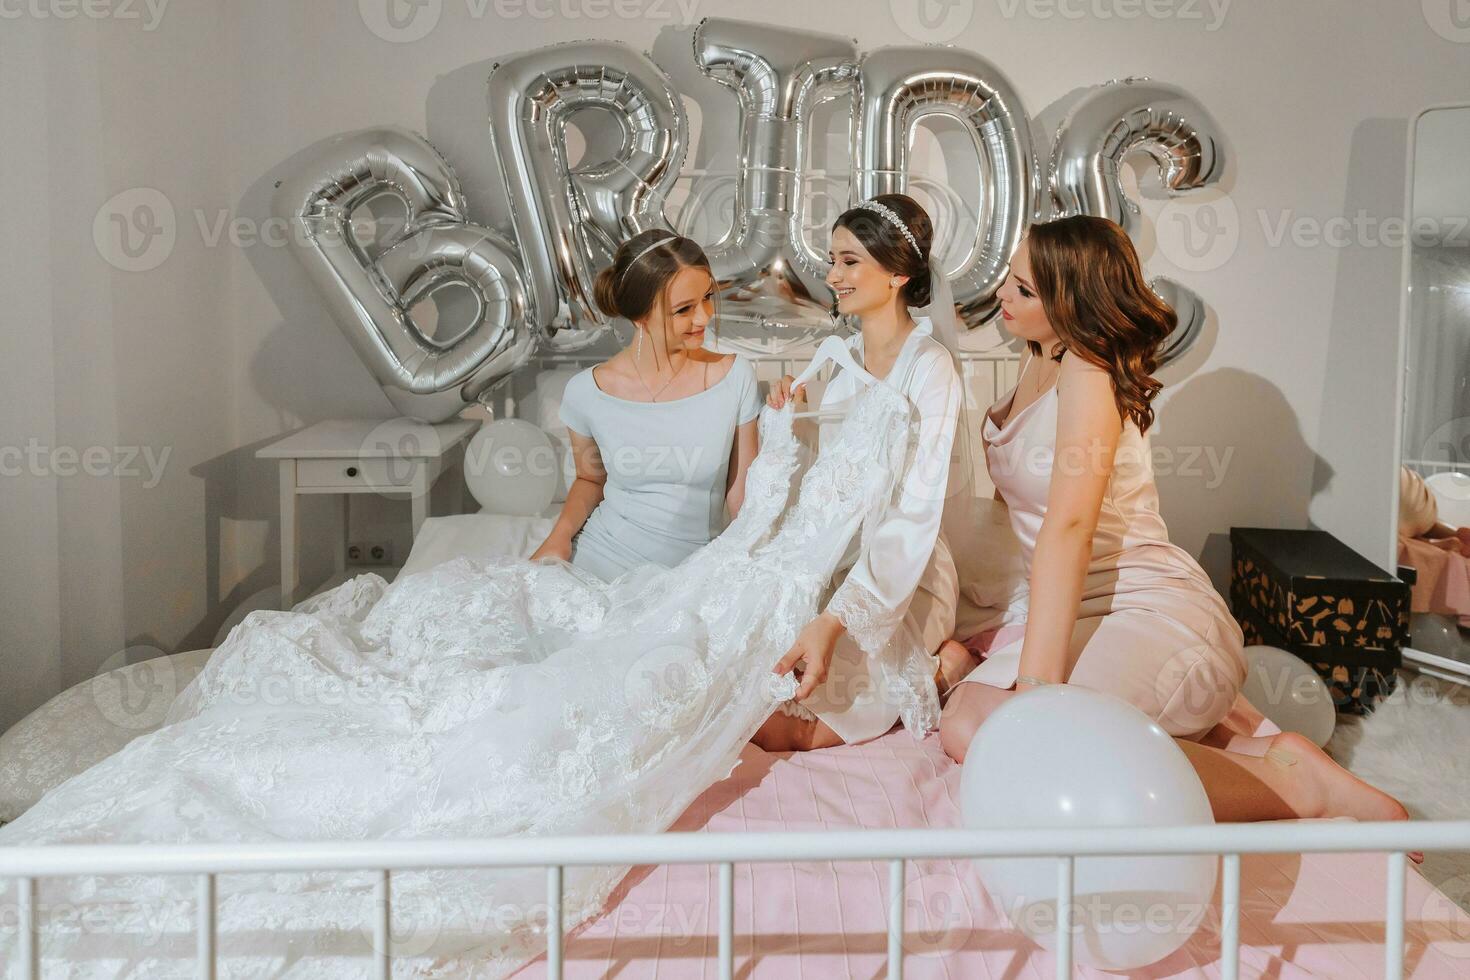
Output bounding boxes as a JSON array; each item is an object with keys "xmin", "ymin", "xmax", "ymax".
[{"xmin": 1327, "ymin": 670, "xmax": 1470, "ymax": 911}]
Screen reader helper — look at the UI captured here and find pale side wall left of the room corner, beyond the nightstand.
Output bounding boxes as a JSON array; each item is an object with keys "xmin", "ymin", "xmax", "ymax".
[{"xmin": 0, "ymin": 0, "xmax": 238, "ymax": 727}]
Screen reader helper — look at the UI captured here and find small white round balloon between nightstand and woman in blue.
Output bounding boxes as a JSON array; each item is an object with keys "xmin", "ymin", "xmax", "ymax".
[{"xmin": 465, "ymin": 419, "xmax": 559, "ymax": 517}]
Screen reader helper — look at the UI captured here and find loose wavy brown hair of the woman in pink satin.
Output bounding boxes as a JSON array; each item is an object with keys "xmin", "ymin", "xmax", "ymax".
[{"xmin": 1026, "ymin": 215, "xmax": 1179, "ymax": 432}]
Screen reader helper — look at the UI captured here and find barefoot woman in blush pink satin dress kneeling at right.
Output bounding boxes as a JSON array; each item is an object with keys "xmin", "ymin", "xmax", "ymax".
[{"xmin": 939, "ymin": 216, "xmax": 1417, "ymax": 857}]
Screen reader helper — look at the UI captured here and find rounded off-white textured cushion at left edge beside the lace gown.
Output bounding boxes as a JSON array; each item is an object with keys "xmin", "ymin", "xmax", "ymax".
[{"xmin": 0, "ymin": 649, "xmax": 213, "ymax": 823}]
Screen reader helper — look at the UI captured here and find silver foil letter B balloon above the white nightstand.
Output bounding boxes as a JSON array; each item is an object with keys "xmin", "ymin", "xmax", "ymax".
[{"xmin": 275, "ymin": 129, "xmax": 535, "ymax": 422}]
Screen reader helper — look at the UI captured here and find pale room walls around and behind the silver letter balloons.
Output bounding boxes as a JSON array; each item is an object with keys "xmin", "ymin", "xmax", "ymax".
[{"xmin": 0, "ymin": 0, "xmax": 1470, "ymax": 724}]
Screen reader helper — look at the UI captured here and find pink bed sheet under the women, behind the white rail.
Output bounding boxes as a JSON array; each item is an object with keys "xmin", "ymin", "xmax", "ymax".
[{"xmin": 516, "ymin": 717, "xmax": 1470, "ymax": 980}]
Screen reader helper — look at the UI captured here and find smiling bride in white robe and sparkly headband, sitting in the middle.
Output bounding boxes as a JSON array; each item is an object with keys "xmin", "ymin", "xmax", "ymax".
[{"xmin": 756, "ymin": 194, "xmax": 973, "ymax": 751}]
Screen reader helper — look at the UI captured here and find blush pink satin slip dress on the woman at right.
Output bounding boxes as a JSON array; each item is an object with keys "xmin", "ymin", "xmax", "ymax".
[{"xmin": 964, "ymin": 360, "xmax": 1247, "ymax": 738}]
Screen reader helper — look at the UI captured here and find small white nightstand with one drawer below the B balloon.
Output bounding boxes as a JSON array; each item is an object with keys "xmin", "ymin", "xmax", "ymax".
[{"xmin": 256, "ymin": 419, "xmax": 479, "ymax": 610}]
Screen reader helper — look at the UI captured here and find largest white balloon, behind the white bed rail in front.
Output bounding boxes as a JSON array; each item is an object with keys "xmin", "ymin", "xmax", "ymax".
[{"xmin": 960, "ymin": 685, "xmax": 1217, "ymax": 970}]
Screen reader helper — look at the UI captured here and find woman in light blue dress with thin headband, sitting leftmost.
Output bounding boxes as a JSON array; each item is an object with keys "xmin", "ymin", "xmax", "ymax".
[{"xmin": 531, "ymin": 231, "xmax": 761, "ymax": 582}]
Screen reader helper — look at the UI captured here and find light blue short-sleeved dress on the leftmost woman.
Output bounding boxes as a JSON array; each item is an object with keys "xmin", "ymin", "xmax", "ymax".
[{"xmin": 562, "ymin": 354, "xmax": 763, "ymax": 582}]
